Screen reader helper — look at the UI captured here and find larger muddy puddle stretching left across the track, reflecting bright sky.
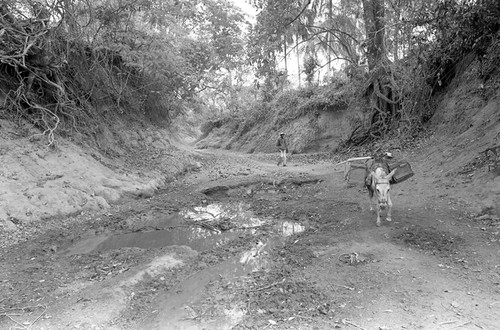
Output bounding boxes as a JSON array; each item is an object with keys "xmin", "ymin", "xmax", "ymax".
[{"xmin": 66, "ymin": 203, "xmax": 306, "ymax": 255}]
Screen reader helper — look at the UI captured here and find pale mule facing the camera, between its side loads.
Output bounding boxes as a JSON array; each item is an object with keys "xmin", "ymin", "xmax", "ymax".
[{"xmin": 365, "ymin": 165, "xmax": 396, "ymax": 226}]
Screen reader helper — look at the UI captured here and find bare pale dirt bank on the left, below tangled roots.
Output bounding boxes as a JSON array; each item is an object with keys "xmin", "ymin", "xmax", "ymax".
[{"xmin": 0, "ymin": 120, "xmax": 198, "ymax": 233}]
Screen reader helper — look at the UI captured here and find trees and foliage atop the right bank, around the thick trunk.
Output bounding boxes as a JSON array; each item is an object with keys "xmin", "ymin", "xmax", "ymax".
[{"xmin": 239, "ymin": 0, "xmax": 500, "ymax": 144}]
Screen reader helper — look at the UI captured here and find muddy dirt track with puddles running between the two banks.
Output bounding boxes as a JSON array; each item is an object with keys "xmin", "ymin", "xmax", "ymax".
[{"xmin": 0, "ymin": 151, "xmax": 500, "ymax": 330}]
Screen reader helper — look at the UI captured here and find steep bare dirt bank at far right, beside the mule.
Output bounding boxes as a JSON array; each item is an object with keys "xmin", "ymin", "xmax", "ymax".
[{"xmin": 417, "ymin": 64, "xmax": 500, "ymax": 216}]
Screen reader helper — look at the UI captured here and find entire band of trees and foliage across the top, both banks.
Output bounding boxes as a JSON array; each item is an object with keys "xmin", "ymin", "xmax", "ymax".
[{"xmin": 0, "ymin": 0, "xmax": 500, "ymax": 148}]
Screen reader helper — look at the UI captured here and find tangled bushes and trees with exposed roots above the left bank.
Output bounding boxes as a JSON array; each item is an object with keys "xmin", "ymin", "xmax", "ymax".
[{"xmin": 0, "ymin": 0, "xmax": 244, "ymax": 144}]
